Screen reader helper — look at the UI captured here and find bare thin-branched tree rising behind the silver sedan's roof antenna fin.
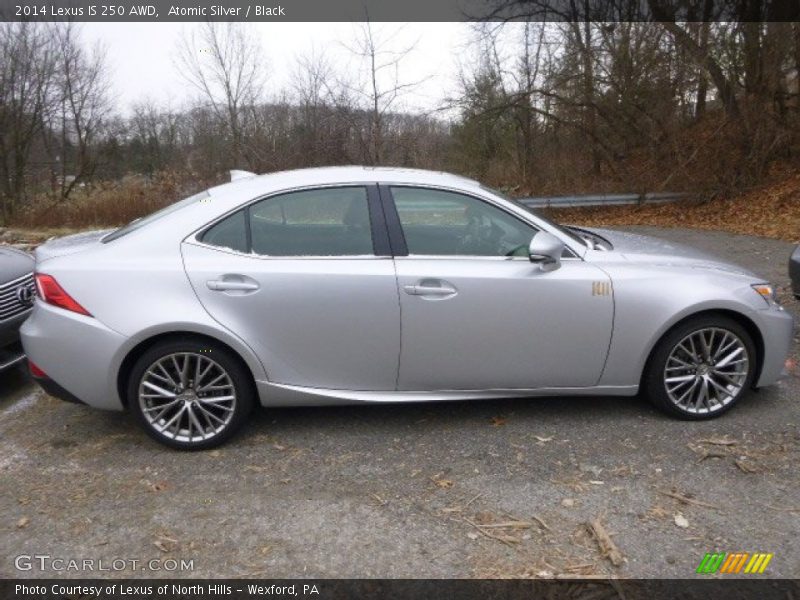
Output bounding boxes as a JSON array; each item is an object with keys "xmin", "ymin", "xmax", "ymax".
[{"xmin": 176, "ymin": 22, "xmax": 265, "ymax": 166}]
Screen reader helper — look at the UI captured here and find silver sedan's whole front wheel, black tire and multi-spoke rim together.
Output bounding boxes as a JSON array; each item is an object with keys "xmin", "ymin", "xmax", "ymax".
[{"xmin": 642, "ymin": 315, "xmax": 758, "ymax": 421}]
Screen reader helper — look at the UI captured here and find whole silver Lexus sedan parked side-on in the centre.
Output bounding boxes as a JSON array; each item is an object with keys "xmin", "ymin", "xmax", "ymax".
[{"xmin": 22, "ymin": 167, "xmax": 793, "ymax": 449}]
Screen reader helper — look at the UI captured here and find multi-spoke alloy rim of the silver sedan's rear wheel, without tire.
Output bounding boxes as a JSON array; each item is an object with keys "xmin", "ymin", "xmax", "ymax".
[{"xmin": 138, "ymin": 352, "xmax": 237, "ymax": 443}]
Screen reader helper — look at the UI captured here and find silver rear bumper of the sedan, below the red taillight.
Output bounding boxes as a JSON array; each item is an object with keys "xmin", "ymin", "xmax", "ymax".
[{"xmin": 20, "ymin": 300, "xmax": 127, "ymax": 410}]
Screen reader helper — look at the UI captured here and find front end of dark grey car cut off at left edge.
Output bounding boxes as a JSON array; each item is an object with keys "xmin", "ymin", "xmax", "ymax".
[{"xmin": 0, "ymin": 246, "xmax": 36, "ymax": 372}]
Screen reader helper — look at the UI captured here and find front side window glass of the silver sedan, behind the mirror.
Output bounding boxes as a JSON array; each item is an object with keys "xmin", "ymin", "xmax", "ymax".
[{"xmin": 391, "ymin": 187, "xmax": 537, "ymax": 256}]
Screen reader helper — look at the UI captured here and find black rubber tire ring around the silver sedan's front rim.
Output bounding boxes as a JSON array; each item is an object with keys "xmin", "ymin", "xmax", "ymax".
[{"xmin": 642, "ymin": 315, "xmax": 758, "ymax": 421}]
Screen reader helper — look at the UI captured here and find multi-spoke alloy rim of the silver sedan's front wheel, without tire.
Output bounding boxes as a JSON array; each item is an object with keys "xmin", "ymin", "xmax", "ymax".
[{"xmin": 664, "ymin": 327, "xmax": 750, "ymax": 414}]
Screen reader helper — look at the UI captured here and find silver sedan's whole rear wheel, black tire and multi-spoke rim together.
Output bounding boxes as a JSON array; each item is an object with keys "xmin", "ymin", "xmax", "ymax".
[{"xmin": 127, "ymin": 338, "xmax": 256, "ymax": 450}]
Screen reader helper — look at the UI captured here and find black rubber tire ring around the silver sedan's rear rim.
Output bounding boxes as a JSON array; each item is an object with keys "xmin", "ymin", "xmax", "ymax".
[{"xmin": 126, "ymin": 339, "xmax": 256, "ymax": 450}]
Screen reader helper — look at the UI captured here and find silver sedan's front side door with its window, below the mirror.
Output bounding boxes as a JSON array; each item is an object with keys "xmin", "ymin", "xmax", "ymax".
[{"xmin": 381, "ymin": 186, "xmax": 613, "ymax": 391}]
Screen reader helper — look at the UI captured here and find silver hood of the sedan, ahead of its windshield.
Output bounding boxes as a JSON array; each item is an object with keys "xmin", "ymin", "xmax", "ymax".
[{"xmin": 584, "ymin": 227, "xmax": 759, "ymax": 279}]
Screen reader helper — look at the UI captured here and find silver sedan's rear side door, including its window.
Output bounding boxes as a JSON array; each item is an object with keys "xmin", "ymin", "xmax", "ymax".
[{"xmin": 182, "ymin": 185, "xmax": 400, "ymax": 391}]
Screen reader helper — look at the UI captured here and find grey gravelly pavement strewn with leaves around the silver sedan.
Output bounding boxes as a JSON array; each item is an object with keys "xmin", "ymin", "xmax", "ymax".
[{"xmin": 0, "ymin": 228, "xmax": 800, "ymax": 578}]
